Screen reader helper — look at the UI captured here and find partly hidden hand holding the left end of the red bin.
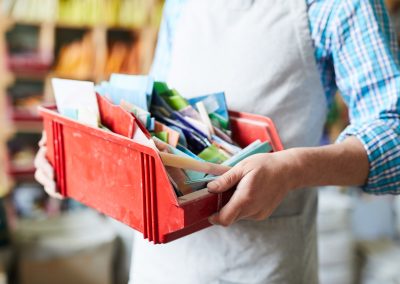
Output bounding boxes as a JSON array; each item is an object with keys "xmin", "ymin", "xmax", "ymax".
[{"xmin": 35, "ymin": 132, "xmax": 64, "ymax": 199}]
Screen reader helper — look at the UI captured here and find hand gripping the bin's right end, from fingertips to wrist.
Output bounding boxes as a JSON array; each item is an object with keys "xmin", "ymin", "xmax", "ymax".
[{"xmin": 207, "ymin": 151, "xmax": 295, "ymax": 226}]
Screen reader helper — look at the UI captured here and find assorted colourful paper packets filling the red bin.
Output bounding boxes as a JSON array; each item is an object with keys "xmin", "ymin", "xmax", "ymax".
[{"xmin": 52, "ymin": 74, "xmax": 272, "ymax": 196}]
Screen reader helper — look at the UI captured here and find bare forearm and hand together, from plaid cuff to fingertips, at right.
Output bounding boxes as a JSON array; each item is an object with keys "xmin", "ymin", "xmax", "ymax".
[{"xmin": 207, "ymin": 137, "xmax": 369, "ymax": 226}]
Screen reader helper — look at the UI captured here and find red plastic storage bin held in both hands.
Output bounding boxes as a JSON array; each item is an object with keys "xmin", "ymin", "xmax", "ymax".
[{"xmin": 36, "ymin": 96, "xmax": 282, "ymax": 244}]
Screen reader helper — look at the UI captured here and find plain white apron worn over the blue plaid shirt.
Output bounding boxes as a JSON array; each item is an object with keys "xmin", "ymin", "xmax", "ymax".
[{"xmin": 131, "ymin": 0, "xmax": 327, "ymax": 284}]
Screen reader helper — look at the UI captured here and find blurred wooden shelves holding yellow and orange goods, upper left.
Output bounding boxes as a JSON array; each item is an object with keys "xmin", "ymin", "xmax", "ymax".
[{"xmin": 0, "ymin": 0, "xmax": 163, "ymax": 193}]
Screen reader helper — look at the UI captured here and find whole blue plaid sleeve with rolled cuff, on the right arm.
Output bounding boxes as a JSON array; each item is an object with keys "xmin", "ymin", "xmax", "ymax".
[{"xmin": 330, "ymin": 0, "xmax": 400, "ymax": 194}]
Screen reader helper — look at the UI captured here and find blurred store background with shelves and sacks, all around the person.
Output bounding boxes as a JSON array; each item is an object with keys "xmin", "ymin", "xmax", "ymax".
[{"xmin": 0, "ymin": 0, "xmax": 400, "ymax": 284}]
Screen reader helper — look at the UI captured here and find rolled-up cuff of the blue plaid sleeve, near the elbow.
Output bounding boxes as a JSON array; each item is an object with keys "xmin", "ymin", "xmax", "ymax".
[{"xmin": 336, "ymin": 120, "xmax": 400, "ymax": 195}]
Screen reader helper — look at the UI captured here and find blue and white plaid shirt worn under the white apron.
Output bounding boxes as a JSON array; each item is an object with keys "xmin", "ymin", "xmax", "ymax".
[{"xmin": 152, "ymin": 0, "xmax": 400, "ymax": 194}]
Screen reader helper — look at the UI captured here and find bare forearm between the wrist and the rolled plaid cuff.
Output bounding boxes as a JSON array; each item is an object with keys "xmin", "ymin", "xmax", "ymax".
[{"xmin": 288, "ymin": 137, "xmax": 369, "ymax": 188}]
